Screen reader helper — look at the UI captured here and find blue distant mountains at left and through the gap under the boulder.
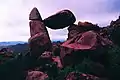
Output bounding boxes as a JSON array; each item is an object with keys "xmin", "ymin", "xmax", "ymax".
[{"xmin": 0, "ymin": 41, "xmax": 63, "ymax": 53}]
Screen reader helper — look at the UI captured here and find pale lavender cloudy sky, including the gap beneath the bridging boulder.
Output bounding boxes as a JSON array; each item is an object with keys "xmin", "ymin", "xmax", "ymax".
[{"xmin": 0, "ymin": 0, "xmax": 120, "ymax": 42}]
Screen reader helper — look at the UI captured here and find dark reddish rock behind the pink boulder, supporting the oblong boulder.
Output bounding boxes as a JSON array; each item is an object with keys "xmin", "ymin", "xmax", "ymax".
[{"xmin": 68, "ymin": 21, "xmax": 100, "ymax": 39}]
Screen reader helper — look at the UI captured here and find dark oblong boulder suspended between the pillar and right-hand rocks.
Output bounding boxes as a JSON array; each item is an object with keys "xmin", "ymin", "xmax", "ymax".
[{"xmin": 44, "ymin": 10, "xmax": 76, "ymax": 29}]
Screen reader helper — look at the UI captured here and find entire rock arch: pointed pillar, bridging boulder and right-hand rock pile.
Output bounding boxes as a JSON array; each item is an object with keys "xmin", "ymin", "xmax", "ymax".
[{"xmin": 26, "ymin": 8, "xmax": 112, "ymax": 80}]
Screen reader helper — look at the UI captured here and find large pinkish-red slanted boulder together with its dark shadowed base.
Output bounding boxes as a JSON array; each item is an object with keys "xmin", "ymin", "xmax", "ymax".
[{"xmin": 60, "ymin": 31, "xmax": 112, "ymax": 66}]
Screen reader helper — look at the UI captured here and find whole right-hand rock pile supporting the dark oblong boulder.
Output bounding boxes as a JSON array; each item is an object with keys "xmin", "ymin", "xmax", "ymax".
[{"xmin": 60, "ymin": 22, "xmax": 113, "ymax": 66}]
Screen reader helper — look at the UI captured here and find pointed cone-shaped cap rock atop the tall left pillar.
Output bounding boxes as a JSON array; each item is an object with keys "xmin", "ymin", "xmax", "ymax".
[{"xmin": 29, "ymin": 7, "xmax": 42, "ymax": 21}]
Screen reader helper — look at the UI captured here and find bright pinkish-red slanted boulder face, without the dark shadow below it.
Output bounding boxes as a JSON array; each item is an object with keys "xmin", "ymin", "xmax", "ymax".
[{"xmin": 61, "ymin": 31, "xmax": 112, "ymax": 50}]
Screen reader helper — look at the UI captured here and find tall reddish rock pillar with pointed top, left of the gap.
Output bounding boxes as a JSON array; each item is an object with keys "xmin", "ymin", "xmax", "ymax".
[{"xmin": 29, "ymin": 8, "xmax": 51, "ymax": 56}]
